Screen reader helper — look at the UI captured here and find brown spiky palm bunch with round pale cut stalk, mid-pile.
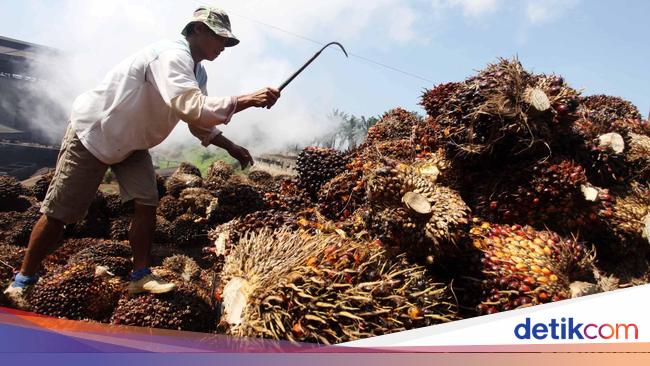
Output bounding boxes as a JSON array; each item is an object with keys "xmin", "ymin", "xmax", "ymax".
[{"xmin": 366, "ymin": 162, "xmax": 469, "ymax": 262}]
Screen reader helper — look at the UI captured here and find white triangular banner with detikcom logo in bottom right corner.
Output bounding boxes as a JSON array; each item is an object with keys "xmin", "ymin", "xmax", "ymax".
[{"xmin": 342, "ymin": 285, "xmax": 650, "ymax": 347}]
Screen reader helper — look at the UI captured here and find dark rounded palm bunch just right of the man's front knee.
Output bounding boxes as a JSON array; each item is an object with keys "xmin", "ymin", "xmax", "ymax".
[{"xmin": 208, "ymin": 184, "xmax": 267, "ymax": 224}]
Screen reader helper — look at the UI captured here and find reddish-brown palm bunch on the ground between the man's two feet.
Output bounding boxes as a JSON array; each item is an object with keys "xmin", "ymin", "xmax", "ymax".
[{"xmin": 27, "ymin": 262, "xmax": 123, "ymax": 320}]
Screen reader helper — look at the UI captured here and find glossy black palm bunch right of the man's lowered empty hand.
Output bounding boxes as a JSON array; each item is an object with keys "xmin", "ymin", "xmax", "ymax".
[{"xmin": 296, "ymin": 146, "xmax": 348, "ymax": 201}]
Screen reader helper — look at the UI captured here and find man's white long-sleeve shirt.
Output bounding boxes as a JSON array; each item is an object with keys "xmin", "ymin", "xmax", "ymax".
[{"xmin": 70, "ymin": 39, "xmax": 237, "ymax": 165}]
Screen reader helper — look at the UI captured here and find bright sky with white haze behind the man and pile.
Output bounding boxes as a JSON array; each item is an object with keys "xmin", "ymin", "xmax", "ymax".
[{"xmin": 0, "ymin": 0, "xmax": 650, "ymax": 151}]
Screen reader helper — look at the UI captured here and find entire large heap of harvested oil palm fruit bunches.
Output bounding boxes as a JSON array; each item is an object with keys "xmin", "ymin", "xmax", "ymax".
[{"xmin": 0, "ymin": 59, "xmax": 650, "ymax": 344}]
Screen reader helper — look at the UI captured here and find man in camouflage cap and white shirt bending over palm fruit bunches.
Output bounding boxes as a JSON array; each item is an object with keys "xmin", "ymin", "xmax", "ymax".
[{"xmin": 5, "ymin": 7, "xmax": 280, "ymax": 307}]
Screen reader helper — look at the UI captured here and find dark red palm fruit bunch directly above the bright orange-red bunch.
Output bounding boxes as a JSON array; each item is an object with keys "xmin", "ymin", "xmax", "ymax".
[{"xmin": 470, "ymin": 157, "xmax": 593, "ymax": 229}]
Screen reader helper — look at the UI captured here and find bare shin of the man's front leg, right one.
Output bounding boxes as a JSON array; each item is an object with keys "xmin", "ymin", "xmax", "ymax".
[{"xmin": 129, "ymin": 203, "xmax": 156, "ymax": 270}]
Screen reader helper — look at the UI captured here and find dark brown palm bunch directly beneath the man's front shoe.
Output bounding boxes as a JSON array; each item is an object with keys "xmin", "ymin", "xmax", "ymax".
[{"xmin": 110, "ymin": 280, "xmax": 216, "ymax": 332}]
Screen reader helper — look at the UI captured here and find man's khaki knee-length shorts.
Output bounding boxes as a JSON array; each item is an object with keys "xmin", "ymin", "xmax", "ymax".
[{"xmin": 41, "ymin": 125, "xmax": 158, "ymax": 224}]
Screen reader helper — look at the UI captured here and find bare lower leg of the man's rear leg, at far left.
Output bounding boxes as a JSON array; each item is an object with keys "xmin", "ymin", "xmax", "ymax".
[{"xmin": 20, "ymin": 215, "xmax": 64, "ymax": 276}]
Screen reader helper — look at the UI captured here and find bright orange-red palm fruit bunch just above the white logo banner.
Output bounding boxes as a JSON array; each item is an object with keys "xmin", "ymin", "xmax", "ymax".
[{"xmin": 470, "ymin": 222, "xmax": 594, "ymax": 314}]
